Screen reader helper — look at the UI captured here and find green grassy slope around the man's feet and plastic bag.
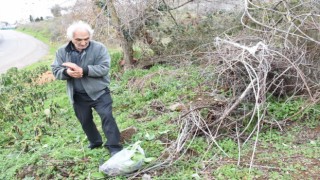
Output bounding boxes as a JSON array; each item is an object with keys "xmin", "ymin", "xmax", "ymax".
[{"xmin": 0, "ymin": 28, "xmax": 320, "ymax": 179}]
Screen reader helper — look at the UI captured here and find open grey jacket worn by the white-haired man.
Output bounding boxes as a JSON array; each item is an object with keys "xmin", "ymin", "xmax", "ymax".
[{"xmin": 51, "ymin": 40, "xmax": 110, "ymax": 104}]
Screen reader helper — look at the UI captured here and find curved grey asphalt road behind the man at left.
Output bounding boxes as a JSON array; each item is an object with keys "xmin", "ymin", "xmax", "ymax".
[{"xmin": 0, "ymin": 30, "xmax": 49, "ymax": 74}]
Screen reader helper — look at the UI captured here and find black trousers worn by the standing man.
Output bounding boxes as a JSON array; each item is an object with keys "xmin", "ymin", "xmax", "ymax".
[{"xmin": 73, "ymin": 89, "xmax": 122, "ymax": 150}]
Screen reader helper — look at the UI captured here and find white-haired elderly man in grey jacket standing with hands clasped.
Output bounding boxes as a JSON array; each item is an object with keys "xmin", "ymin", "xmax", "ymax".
[{"xmin": 51, "ymin": 21, "xmax": 122, "ymax": 156}]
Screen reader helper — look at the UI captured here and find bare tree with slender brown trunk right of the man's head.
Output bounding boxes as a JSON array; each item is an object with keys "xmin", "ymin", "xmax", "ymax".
[{"xmin": 96, "ymin": 0, "xmax": 198, "ymax": 69}]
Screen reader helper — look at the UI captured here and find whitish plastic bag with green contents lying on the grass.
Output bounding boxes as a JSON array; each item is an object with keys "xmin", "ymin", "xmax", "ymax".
[{"xmin": 99, "ymin": 141, "xmax": 145, "ymax": 176}]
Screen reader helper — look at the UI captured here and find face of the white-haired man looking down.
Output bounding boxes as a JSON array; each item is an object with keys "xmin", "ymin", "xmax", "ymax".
[{"xmin": 72, "ymin": 29, "xmax": 90, "ymax": 52}]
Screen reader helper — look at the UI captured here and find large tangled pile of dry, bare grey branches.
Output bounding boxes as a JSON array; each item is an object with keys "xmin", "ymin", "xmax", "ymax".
[{"xmin": 131, "ymin": 0, "xmax": 320, "ymax": 175}]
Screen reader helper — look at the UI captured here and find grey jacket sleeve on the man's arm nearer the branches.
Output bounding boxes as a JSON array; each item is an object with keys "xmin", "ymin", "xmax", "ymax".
[{"xmin": 87, "ymin": 45, "xmax": 111, "ymax": 77}]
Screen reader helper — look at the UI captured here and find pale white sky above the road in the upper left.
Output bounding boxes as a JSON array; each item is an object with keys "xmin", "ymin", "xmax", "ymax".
[{"xmin": 0, "ymin": 0, "xmax": 76, "ymax": 24}]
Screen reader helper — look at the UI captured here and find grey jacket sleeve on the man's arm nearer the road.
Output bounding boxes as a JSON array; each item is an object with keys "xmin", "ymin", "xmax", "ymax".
[{"xmin": 51, "ymin": 49, "xmax": 71, "ymax": 80}]
